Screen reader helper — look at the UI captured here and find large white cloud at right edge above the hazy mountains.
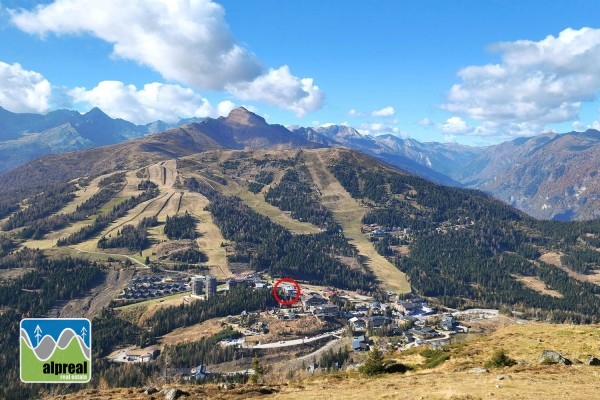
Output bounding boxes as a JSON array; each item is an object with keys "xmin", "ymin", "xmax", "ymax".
[{"xmin": 442, "ymin": 28, "xmax": 600, "ymax": 136}]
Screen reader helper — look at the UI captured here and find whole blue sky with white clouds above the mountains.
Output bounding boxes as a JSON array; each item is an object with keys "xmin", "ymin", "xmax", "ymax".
[{"xmin": 0, "ymin": 0, "xmax": 600, "ymax": 145}]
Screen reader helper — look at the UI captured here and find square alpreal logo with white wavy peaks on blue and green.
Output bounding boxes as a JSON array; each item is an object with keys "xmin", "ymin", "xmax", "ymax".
[{"xmin": 19, "ymin": 318, "xmax": 92, "ymax": 383}]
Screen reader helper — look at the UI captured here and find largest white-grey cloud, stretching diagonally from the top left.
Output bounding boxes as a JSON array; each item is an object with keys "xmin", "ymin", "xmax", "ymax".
[{"xmin": 9, "ymin": 0, "xmax": 323, "ymax": 115}]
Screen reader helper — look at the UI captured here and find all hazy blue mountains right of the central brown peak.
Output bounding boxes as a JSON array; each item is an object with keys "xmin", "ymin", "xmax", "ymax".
[{"xmin": 293, "ymin": 125, "xmax": 600, "ymax": 220}]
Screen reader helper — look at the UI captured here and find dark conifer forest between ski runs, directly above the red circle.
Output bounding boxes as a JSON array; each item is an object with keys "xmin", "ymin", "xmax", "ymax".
[{"xmin": 185, "ymin": 178, "xmax": 375, "ymax": 291}]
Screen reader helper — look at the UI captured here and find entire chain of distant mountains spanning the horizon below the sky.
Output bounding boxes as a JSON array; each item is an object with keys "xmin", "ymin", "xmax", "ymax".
[{"xmin": 0, "ymin": 108, "xmax": 600, "ymax": 220}]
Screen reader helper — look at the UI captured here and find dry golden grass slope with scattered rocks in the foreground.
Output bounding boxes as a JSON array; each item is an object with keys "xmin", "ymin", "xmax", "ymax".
[{"xmin": 45, "ymin": 324, "xmax": 599, "ymax": 400}]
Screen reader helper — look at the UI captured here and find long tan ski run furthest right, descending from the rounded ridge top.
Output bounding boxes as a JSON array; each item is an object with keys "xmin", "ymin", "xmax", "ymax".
[{"xmin": 303, "ymin": 150, "xmax": 410, "ymax": 293}]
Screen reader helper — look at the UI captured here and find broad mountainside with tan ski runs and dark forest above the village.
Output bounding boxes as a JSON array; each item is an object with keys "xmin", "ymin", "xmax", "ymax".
[{"xmin": 2, "ymin": 143, "xmax": 600, "ymax": 316}]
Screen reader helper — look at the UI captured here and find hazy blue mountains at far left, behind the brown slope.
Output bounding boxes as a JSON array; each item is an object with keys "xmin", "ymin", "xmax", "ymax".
[{"xmin": 0, "ymin": 107, "xmax": 203, "ymax": 172}]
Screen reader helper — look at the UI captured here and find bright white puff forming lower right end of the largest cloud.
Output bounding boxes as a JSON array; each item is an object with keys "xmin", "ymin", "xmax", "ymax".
[{"xmin": 227, "ymin": 65, "xmax": 325, "ymax": 117}]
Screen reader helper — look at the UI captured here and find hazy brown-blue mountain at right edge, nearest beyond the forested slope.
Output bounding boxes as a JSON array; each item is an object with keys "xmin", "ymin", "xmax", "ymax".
[{"xmin": 462, "ymin": 129, "xmax": 600, "ymax": 220}]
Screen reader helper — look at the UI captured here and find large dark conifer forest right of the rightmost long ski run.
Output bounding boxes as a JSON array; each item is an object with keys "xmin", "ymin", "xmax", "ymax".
[{"xmin": 330, "ymin": 157, "xmax": 600, "ymax": 323}]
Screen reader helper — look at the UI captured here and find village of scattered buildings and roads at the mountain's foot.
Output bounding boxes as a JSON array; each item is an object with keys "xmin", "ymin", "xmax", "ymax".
[{"xmin": 109, "ymin": 273, "xmax": 498, "ymax": 380}]
